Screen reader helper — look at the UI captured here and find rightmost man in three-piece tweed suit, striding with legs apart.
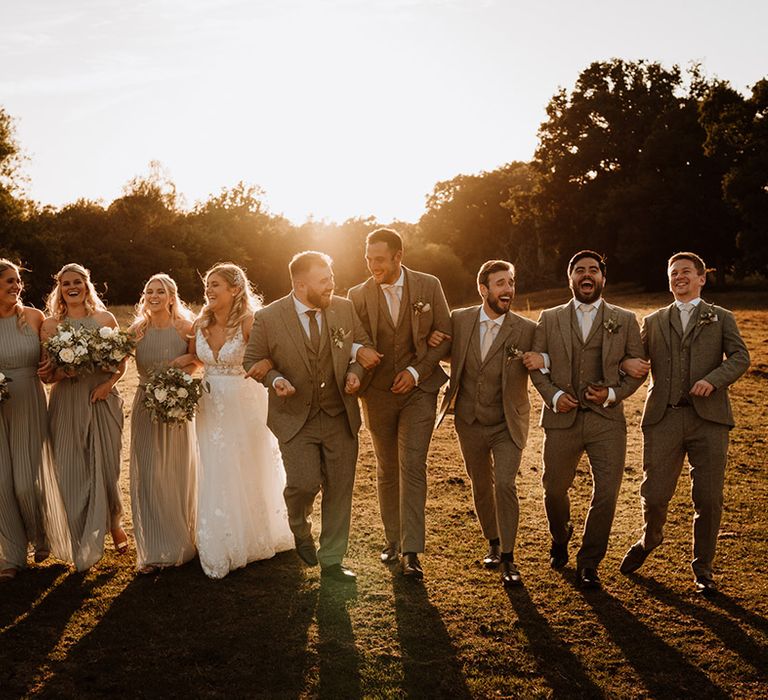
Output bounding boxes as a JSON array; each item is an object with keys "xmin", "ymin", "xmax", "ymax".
[{"xmin": 621, "ymin": 252, "xmax": 749, "ymax": 594}]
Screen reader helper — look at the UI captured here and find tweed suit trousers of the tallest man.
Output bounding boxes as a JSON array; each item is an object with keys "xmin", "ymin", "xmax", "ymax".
[{"xmin": 362, "ymin": 387, "xmax": 437, "ymax": 553}]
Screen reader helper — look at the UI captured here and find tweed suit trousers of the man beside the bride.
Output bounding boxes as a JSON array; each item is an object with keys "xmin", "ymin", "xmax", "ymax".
[{"xmin": 279, "ymin": 411, "xmax": 357, "ymax": 567}]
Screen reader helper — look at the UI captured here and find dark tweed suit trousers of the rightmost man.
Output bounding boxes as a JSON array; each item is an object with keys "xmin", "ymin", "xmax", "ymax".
[{"xmin": 640, "ymin": 406, "xmax": 729, "ymax": 578}]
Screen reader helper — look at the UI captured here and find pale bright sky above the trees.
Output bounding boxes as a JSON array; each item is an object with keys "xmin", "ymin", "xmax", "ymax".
[{"xmin": 0, "ymin": 0, "xmax": 768, "ymax": 224}]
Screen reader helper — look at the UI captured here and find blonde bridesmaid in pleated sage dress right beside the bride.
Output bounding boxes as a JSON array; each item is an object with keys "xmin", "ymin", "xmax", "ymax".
[{"xmin": 130, "ymin": 273, "xmax": 197, "ymax": 574}]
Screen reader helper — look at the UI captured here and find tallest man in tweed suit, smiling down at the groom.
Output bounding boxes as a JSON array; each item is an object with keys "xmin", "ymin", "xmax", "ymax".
[{"xmin": 349, "ymin": 228, "xmax": 451, "ymax": 580}]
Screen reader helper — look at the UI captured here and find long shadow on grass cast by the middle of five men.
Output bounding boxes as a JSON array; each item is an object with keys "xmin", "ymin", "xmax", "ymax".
[{"xmin": 506, "ymin": 588, "xmax": 605, "ymax": 698}]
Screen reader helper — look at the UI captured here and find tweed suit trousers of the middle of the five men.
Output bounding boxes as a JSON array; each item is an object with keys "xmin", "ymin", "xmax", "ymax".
[{"xmin": 454, "ymin": 415, "xmax": 523, "ymax": 552}]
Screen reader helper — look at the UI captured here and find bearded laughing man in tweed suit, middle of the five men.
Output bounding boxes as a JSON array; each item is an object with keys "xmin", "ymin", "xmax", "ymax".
[{"xmin": 438, "ymin": 260, "xmax": 536, "ymax": 587}]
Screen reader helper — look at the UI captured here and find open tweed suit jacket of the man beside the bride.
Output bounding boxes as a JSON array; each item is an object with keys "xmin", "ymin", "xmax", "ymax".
[{"xmin": 243, "ymin": 294, "xmax": 370, "ymax": 442}]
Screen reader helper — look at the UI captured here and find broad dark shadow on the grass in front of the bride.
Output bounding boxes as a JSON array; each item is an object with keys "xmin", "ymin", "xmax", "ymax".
[{"xmin": 35, "ymin": 553, "xmax": 318, "ymax": 698}]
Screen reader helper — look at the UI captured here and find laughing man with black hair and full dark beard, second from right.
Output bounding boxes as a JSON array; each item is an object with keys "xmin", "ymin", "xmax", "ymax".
[{"xmin": 524, "ymin": 250, "xmax": 643, "ymax": 588}]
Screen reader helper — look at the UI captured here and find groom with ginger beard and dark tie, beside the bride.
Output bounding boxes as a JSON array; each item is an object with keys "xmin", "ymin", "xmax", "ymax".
[{"xmin": 243, "ymin": 251, "xmax": 370, "ymax": 583}]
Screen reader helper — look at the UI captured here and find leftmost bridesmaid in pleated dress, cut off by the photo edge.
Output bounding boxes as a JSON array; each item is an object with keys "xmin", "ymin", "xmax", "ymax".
[{"xmin": 0, "ymin": 259, "xmax": 58, "ymax": 582}]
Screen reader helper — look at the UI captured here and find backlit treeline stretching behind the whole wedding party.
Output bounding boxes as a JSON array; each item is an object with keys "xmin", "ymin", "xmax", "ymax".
[{"xmin": 0, "ymin": 59, "xmax": 768, "ymax": 304}]
